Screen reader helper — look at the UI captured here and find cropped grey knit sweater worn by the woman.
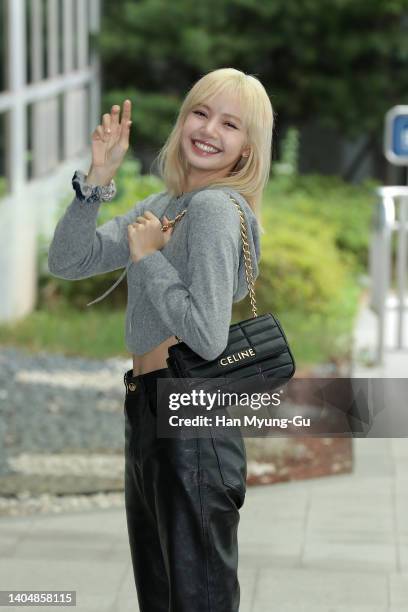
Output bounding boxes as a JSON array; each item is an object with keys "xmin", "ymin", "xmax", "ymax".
[{"xmin": 48, "ymin": 186, "xmax": 260, "ymax": 360}]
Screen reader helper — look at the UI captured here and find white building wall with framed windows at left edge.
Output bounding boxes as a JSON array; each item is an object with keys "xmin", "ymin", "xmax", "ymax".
[{"xmin": 0, "ymin": 0, "xmax": 100, "ymax": 322}]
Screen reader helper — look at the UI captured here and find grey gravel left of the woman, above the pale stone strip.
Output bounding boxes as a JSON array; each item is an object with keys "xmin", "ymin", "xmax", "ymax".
[{"xmin": 0, "ymin": 348, "xmax": 131, "ymax": 466}]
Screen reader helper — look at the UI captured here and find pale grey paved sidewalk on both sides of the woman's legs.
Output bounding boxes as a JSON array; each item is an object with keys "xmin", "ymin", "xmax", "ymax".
[{"xmin": 0, "ymin": 294, "xmax": 408, "ymax": 612}]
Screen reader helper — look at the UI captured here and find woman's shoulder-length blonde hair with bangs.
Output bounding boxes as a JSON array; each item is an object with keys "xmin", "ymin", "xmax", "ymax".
[{"xmin": 153, "ymin": 68, "xmax": 274, "ymax": 233}]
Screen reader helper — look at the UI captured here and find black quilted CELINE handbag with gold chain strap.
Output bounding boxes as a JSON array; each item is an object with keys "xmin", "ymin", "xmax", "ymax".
[{"xmin": 166, "ymin": 195, "xmax": 296, "ymax": 390}]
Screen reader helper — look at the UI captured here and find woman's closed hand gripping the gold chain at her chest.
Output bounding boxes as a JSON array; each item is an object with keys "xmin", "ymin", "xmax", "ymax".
[{"xmin": 127, "ymin": 210, "xmax": 173, "ymax": 262}]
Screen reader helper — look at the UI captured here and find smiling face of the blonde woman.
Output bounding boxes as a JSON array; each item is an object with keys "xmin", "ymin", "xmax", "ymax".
[{"xmin": 181, "ymin": 93, "xmax": 250, "ymax": 191}]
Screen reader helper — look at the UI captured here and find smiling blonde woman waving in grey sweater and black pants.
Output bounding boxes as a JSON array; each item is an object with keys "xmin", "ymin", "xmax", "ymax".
[{"xmin": 48, "ymin": 68, "xmax": 273, "ymax": 612}]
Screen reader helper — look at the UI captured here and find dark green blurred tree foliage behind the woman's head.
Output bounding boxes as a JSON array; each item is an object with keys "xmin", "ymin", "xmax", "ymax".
[{"xmin": 94, "ymin": 0, "xmax": 408, "ymax": 158}]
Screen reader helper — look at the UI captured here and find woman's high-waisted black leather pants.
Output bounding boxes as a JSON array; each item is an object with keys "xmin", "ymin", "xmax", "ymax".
[{"xmin": 124, "ymin": 368, "xmax": 247, "ymax": 612}]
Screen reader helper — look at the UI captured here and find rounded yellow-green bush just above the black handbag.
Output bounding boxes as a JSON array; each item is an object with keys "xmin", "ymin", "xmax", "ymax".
[{"xmin": 234, "ymin": 212, "xmax": 352, "ymax": 316}]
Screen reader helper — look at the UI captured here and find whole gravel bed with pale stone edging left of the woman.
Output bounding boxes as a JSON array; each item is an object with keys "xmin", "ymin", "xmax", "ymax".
[{"xmin": 0, "ymin": 347, "xmax": 132, "ymax": 515}]
